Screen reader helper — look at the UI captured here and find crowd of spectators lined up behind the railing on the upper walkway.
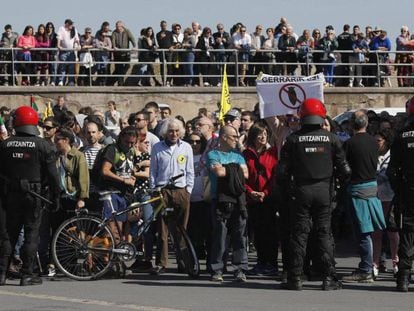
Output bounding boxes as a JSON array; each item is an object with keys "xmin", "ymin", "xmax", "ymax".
[{"xmin": 0, "ymin": 17, "xmax": 414, "ymax": 87}]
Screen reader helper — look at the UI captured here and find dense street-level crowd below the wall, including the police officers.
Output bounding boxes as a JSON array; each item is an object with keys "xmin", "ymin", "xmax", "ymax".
[{"xmin": 0, "ymin": 96, "xmax": 414, "ymax": 291}]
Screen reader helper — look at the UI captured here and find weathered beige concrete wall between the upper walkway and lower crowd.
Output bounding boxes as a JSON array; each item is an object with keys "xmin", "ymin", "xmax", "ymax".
[{"xmin": 0, "ymin": 87, "xmax": 414, "ymax": 120}]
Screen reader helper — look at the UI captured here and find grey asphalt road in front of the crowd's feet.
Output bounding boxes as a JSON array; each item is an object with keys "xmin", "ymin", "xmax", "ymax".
[{"xmin": 0, "ymin": 241, "xmax": 414, "ymax": 311}]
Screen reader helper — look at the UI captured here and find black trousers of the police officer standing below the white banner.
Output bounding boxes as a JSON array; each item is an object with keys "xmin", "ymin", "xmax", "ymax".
[{"xmin": 288, "ymin": 180, "xmax": 335, "ymax": 279}]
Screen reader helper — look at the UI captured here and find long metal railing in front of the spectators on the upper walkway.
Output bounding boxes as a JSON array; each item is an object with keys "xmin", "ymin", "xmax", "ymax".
[{"xmin": 0, "ymin": 48, "xmax": 414, "ymax": 86}]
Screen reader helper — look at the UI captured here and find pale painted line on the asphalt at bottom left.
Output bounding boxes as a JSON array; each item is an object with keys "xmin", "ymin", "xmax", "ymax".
[{"xmin": 0, "ymin": 290, "xmax": 184, "ymax": 311}]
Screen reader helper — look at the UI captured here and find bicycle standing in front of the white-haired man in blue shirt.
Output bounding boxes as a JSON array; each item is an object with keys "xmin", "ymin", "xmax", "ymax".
[{"xmin": 51, "ymin": 175, "xmax": 200, "ymax": 281}]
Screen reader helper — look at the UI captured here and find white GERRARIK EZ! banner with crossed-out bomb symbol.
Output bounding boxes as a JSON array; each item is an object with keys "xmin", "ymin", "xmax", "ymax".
[{"xmin": 256, "ymin": 74, "xmax": 324, "ymax": 118}]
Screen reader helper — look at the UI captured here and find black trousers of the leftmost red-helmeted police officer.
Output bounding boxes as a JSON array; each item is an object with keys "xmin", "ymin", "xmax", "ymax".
[{"xmin": 0, "ymin": 191, "xmax": 42, "ymax": 277}]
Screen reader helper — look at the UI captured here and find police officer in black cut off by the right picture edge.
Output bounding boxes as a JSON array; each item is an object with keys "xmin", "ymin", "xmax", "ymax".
[{"xmin": 387, "ymin": 97, "xmax": 414, "ymax": 292}]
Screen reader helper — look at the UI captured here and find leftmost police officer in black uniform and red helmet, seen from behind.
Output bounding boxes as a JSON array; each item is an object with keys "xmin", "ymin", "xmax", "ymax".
[{"xmin": 0, "ymin": 106, "xmax": 60, "ymax": 286}]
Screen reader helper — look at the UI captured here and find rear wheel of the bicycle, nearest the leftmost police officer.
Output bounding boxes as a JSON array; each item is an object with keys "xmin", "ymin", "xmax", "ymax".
[{"xmin": 52, "ymin": 216, "xmax": 115, "ymax": 281}]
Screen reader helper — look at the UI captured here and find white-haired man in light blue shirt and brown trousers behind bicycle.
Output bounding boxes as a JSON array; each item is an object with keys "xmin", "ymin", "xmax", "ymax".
[{"xmin": 150, "ymin": 118, "xmax": 194, "ymax": 275}]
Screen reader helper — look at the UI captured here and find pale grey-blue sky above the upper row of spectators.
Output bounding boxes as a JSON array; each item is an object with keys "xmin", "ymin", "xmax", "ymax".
[{"xmin": 0, "ymin": 0, "xmax": 414, "ymax": 44}]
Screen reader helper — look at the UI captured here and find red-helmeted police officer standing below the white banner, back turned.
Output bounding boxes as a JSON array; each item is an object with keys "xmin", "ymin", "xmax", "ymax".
[{"xmin": 278, "ymin": 98, "xmax": 350, "ymax": 290}]
